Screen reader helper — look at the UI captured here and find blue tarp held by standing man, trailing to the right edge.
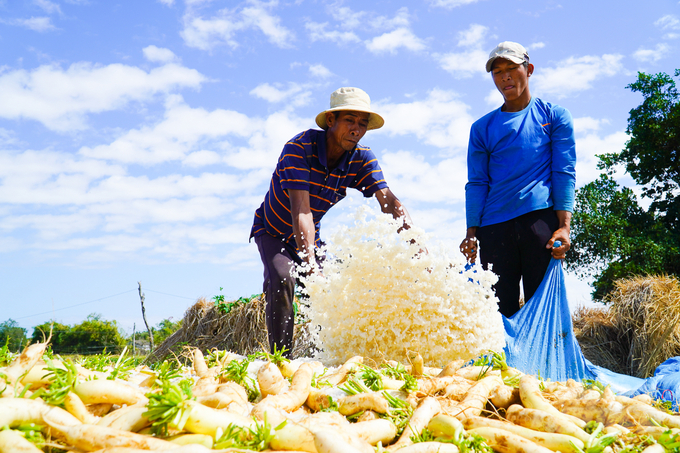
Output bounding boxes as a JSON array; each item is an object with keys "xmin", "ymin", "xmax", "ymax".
[{"xmin": 503, "ymin": 259, "xmax": 680, "ymax": 400}]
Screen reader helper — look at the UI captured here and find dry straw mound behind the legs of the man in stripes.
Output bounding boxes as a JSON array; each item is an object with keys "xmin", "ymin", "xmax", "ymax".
[{"xmin": 147, "ymin": 294, "xmax": 313, "ymax": 362}]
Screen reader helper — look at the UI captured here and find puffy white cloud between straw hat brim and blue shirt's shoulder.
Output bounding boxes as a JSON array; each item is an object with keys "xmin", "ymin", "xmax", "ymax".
[{"xmin": 373, "ymin": 89, "xmax": 474, "ymax": 151}]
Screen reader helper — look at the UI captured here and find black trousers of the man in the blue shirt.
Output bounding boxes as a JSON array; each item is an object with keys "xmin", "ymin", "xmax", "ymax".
[{"xmin": 477, "ymin": 208, "xmax": 559, "ymax": 318}]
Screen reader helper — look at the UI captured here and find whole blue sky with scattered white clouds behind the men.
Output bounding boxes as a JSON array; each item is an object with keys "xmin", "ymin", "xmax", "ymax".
[{"xmin": 0, "ymin": 0, "xmax": 680, "ymax": 333}]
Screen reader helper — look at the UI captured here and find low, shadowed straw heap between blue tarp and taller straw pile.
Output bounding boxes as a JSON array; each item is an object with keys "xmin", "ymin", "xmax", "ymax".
[{"xmin": 572, "ymin": 307, "xmax": 629, "ymax": 373}]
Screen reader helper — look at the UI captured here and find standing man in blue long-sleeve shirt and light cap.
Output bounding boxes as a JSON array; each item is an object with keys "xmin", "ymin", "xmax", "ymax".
[{"xmin": 460, "ymin": 41, "xmax": 576, "ymax": 317}]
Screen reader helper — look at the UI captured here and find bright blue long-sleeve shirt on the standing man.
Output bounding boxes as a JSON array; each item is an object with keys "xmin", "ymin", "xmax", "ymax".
[{"xmin": 465, "ymin": 98, "xmax": 576, "ymax": 228}]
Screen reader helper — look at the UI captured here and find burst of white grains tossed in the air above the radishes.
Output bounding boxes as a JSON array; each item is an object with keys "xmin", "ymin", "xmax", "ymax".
[{"xmin": 295, "ymin": 206, "xmax": 505, "ymax": 366}]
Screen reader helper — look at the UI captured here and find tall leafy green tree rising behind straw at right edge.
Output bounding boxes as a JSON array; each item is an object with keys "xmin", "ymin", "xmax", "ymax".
[{"xmin": 567, "ymin": 70, "xmax": 680, "ymax": 299}]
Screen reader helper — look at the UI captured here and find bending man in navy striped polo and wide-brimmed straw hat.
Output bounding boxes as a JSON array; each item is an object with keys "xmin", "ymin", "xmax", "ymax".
[{"xmin": 250, "ymin": 88, "xmax": 410, "ymax": 355}]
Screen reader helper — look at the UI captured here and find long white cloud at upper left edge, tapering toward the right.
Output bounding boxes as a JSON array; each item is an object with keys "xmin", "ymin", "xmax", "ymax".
[{"xmin": 0, "ymin": 62, "xmax": 205, "ymax": 131}]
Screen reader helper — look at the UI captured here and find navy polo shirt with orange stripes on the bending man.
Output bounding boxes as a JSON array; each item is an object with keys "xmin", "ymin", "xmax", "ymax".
[{"xmin": 250, "ymin": 129, "xmax": 387, "ymax": 248}]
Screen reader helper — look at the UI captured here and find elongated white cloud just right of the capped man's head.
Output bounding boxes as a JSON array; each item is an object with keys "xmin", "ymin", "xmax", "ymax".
[{"xmin": 532, "ymin": 54, "xmax": 623, "ymax": 99}]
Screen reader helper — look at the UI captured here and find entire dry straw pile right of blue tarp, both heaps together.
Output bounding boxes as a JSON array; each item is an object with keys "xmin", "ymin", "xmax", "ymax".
[{"xmin": 574, "ymin": 276, "xmax": 680, "ymax": 378}]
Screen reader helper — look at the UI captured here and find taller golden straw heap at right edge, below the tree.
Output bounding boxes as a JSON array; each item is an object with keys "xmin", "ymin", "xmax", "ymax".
[{"xmin": 607, "ymin": 276, "xmax": 680, "ymax": 378}]
